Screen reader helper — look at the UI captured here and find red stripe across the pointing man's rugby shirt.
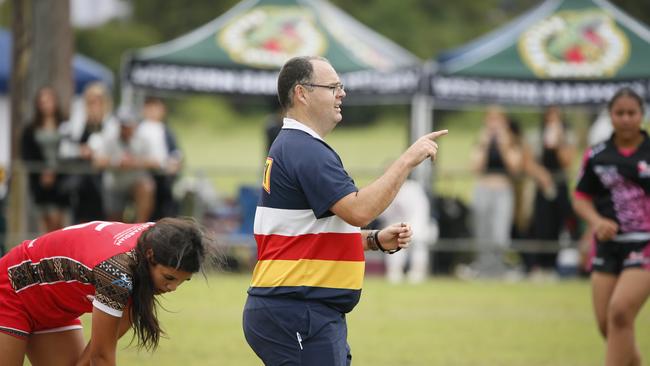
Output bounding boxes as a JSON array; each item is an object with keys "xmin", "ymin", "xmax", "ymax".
[{"xmin": 255, "ymin": 233, "xmax": 365, "ymax": 261}]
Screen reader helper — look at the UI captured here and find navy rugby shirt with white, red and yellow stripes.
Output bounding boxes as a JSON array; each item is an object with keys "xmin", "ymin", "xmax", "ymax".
[{"xmin": 248, "ymin": 118, "xmax": 365, "ymax": 312}]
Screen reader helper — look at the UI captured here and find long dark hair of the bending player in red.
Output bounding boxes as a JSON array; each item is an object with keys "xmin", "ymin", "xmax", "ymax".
[{"xmin": 131, "ymin": 218, "xmax": 210, "ymax": 350}]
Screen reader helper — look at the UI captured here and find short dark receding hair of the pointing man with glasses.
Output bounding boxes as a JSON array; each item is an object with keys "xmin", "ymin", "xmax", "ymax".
[{"xmin": 278, "ymin": 56, "xmax": 329, "ymax": 110}]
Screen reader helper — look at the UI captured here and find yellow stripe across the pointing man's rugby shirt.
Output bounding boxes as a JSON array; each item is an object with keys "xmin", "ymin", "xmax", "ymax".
[{"xmin": 251, "ymin": 259, "xmax": 365, "ymax": 290}]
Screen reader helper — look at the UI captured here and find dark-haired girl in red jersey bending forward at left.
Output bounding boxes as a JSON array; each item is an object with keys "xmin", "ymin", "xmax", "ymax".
[{"xmin": 0, "ymin": 218, "xmax": 207, "ymax": 366}]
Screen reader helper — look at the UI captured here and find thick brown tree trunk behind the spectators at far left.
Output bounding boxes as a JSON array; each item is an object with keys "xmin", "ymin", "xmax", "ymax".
[{"xmin": 7, "ymin": 0, "xmax": 73, "ymax": 246}]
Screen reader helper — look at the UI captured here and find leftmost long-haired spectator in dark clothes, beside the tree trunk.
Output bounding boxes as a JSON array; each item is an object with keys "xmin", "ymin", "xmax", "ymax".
[{"xmin": 20, "ymin": 87, "xmax": 69, "ymax": 232}]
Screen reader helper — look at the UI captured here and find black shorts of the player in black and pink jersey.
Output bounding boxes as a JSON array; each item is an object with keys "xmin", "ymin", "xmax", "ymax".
[{"xmin": 591, "ymin": 241, "xmax": 650, "ymax": 274}]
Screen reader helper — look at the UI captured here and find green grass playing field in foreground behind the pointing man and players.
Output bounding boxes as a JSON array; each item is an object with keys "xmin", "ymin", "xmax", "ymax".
[{"xmin": 92, "ymin": 274, "xmax": 650, "ymax": 366}]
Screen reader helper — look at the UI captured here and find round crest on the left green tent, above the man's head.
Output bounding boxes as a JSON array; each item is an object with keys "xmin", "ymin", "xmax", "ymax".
[{"xmin": 217, "ymin": 6, "xmax": 327, "ymax": 69}]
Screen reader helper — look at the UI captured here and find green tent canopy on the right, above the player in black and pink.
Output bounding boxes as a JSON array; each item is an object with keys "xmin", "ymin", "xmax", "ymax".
[{"xmin": 430, "ymin": 0, "xmax": 650, "ymax": 105}]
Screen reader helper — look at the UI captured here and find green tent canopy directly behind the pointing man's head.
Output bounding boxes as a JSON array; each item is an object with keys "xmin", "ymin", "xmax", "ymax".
[{"xmin": 124, "ymin": 0, "xmax": 420, "ymax": 96}]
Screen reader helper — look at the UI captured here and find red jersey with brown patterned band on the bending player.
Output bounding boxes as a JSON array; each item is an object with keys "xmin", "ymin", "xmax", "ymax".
[{"xmin": 3, "ymin": 221, "xmax": 153, "ymax": 321}]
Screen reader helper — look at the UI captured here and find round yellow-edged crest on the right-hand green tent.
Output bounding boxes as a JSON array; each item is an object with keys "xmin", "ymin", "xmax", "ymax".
[{"xmin": 519, "ymin": 10, "xmax": 630, "ymax": 78}]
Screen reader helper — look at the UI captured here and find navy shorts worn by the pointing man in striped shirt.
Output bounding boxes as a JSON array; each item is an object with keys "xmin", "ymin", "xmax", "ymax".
[{"xmin": 244, "ymin": 295, "xmax": 352, "ymax": 366}]
